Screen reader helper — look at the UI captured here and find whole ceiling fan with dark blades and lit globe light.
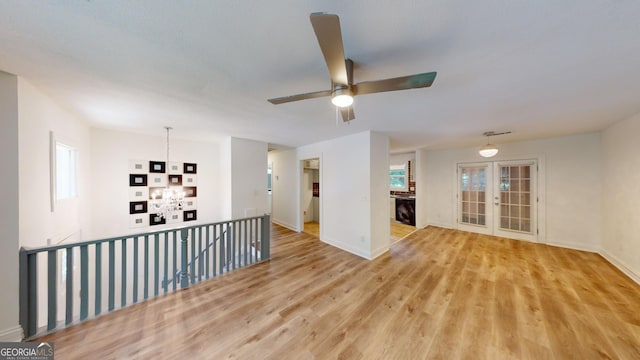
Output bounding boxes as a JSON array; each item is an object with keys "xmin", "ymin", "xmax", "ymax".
[{"xmin": 268, "ymin": 13, "xmax": 436, "ymax": 122}]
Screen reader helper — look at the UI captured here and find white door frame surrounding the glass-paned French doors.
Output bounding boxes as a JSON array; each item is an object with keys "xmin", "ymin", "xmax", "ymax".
[{"xmin": 451, "ymin": 154, "xmax": 546, "ymax": 243}]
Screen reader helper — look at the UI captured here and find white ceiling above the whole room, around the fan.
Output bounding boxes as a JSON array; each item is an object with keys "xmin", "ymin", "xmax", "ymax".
[{"xmin": 0, "ymin": 0, "xmax": 640, "ymax": 152}]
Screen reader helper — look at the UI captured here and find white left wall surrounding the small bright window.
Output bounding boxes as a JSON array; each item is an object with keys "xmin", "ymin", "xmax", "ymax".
[{"xmin": 18, "ymin": 78, "xmax": 92, "ymax": 246}]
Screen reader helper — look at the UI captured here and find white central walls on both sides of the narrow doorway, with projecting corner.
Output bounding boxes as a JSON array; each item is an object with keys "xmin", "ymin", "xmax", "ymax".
[{"xmin": 269, "ymin": 131, "xmax": 389, "ymax": 259}]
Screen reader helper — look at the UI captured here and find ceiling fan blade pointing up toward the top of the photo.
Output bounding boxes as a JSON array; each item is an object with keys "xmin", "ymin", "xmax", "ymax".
[{"xmin": 309, "ymin": 13, "xmax": 349, "ymax": 85}]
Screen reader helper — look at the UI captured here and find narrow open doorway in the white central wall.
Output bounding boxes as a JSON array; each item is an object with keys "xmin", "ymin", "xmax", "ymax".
[{"xmin": 302, "ymin": 158, "xmax": 320, "ymax": 238}]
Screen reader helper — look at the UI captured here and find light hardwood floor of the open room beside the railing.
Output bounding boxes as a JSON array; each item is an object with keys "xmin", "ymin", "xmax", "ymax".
[{"xmin": 36, "ymin": 226, "xmax": 640, "ymax": 359}]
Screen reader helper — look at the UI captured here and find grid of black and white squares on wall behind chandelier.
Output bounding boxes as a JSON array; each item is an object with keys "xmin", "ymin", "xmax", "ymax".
[{"xmin": 129, "ymin": 160, "xmax": 198, "ymax": 228}]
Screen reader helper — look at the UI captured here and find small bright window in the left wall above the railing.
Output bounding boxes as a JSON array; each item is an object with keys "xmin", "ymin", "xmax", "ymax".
[{"xmin": 56, "ymin": 142, "xmax": 78, "ymax": 200}]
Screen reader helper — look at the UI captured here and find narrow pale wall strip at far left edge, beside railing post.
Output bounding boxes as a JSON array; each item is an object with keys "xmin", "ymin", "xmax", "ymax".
[{"xmin": 0, "ymin": 71, "xmax": 22, "ymax": 341}]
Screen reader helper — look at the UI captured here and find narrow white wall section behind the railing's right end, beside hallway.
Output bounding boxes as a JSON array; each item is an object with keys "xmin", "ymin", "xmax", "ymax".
[{"xmin": 230, "ymin": 138, "xmax": 269, "ymax": 219}]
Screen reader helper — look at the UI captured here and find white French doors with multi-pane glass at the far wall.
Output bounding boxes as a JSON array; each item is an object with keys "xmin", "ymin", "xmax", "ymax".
[{"xmin": 457, "ymin": 160, "xmax": 538, "ymax": 241}]
